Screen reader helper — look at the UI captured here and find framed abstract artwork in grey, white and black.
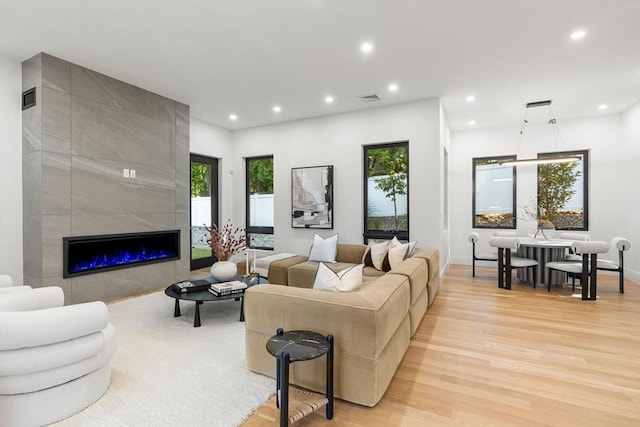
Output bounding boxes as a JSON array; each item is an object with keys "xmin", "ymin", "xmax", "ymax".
[{"xmin": 291, "ymin": 165, "xmax": 333, "ymax": 228}]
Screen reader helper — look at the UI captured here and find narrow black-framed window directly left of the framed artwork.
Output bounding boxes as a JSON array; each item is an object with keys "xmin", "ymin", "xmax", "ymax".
[{"xmin": 245, "ymin": 156, "xmax": 274, "ymax": 249}]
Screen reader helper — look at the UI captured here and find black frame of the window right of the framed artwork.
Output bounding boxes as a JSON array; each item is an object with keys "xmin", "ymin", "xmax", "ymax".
[{"xmin": 362, "ymin": 140, "xmax": 411, "ymax": 245}]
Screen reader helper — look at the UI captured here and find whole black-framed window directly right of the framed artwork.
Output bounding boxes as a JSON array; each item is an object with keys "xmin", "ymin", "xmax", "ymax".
[{"xmin": 364, "ymin": 142, "xmax": 409, "ymax": 243}]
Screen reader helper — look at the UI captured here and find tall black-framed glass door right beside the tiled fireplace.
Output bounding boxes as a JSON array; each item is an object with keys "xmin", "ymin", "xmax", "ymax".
[{"xmin": 191, "ymin": 154, "xmax": 218, "ymax": 270}]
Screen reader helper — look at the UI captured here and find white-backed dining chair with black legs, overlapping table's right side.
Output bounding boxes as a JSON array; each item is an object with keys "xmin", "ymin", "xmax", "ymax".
[{"xmin": 546, "ymin": 240, "xmax": 609, "ymax": 300}]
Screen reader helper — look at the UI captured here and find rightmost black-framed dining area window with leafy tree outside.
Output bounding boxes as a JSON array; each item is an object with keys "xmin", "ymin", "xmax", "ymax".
[{"xmin": 538, "ymin": 150, "xmax": 589, "ymax": 231}]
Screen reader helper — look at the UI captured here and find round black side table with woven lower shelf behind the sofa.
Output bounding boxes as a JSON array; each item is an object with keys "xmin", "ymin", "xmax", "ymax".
[{"xmin": 267, "ymin": 328, "xmax": 333, "ymax": 427}]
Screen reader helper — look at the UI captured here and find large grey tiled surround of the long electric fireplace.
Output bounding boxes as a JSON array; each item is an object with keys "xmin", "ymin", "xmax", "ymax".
[{"xmin": 22, "ymin": 53, "xmax": 190, "ymax": 304}]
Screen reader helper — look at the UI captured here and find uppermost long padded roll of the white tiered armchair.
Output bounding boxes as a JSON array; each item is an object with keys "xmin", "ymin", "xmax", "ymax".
[{"xmin": 0, "ymin": 301, "xmax": 109, "ymax": 350}]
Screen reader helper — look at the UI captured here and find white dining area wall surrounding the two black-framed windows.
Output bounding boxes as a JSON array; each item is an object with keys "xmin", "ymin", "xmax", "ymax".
[{"xmin": 449, "ymin": 111, "xmax": 640, "ymax": 282}]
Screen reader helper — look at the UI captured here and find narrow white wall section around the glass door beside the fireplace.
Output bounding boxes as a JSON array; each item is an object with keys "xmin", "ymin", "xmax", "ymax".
[{"xmin": 189, "ymin": 117, "xmax": 235, "ymax": 223}]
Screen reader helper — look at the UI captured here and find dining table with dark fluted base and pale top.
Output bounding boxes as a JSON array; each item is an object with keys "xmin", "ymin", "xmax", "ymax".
[{"xmin": 517, "ymin": 237, "xmax": 573, "ymax": 285}]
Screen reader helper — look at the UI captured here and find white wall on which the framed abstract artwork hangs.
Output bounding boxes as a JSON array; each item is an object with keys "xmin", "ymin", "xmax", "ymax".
[{"xmin": 232, "ymin": 99, "xmax": 442, "ymax": 260}]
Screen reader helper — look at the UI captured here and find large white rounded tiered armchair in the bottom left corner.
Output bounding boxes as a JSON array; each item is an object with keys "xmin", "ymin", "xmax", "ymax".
[{"xmin": 0, "ymin": 286, "xmax": 116, "ymax": 427}]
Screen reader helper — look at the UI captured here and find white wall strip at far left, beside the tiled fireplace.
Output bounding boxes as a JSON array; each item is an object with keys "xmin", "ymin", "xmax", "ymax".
[{"xmin": 0, "ymin": 57, "xmax": 23, "ymax": 284}]
